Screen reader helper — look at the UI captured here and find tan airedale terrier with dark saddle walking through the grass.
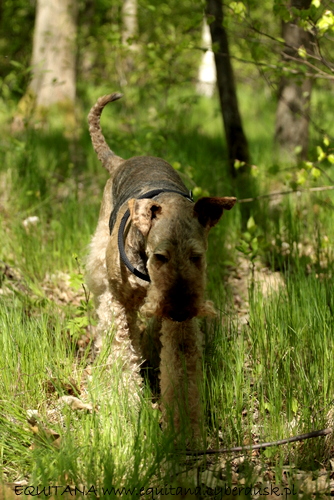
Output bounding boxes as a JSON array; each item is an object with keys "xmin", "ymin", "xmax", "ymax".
[{"xmin": 87, "ymin": 93, "xmax": 236, "ymax": 433}]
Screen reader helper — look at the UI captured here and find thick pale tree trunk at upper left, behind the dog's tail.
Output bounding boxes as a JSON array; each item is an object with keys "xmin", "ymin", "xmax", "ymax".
[{"xmin": 30, "ymin": 0, "xmax": 77, "ymax": 108}]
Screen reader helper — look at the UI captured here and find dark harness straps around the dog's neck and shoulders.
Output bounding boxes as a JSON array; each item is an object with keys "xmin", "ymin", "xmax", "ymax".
[{"xmin": 109, "ymin": 189, "xmax": 194, "ymax": 282}]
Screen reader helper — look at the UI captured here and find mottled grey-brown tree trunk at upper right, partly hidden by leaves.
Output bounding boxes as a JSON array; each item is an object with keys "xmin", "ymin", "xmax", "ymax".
[{"xmin": 275, "ymin": 0, "xmax": 312, "ymax": 159}]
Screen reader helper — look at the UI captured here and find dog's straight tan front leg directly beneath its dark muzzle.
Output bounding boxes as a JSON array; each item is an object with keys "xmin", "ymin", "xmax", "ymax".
[{"xmin": 160, "ymin": 318, "xmax": 203, "ymax": 438}]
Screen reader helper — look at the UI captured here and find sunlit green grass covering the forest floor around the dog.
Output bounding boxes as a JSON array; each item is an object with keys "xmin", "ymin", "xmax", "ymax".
[{"xmin": 0, "ymin": 86, "xmax": 334, "ymax": 498}]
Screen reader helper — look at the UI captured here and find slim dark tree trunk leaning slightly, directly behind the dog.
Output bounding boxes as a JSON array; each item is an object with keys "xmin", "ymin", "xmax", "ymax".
[{"xmin": 206, "ymin": 0, "xmax": 249, "ymax": 176}]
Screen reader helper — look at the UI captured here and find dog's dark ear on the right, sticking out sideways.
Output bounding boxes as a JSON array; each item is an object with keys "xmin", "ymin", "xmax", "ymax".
[{"xmin": 194, "ymin": 196, "xmax": 237, "ymax": 229}]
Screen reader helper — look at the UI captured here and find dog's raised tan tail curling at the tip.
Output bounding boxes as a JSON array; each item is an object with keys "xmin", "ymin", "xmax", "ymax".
[{"xmin": 88, "ymin": 92, "xmax": 124, "ymax": 173}]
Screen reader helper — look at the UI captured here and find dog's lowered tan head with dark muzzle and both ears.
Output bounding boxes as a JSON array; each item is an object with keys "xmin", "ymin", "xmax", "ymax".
[{"xmin": 129, "ymin": 193, "xmax": 236, "ymax": 321}]
